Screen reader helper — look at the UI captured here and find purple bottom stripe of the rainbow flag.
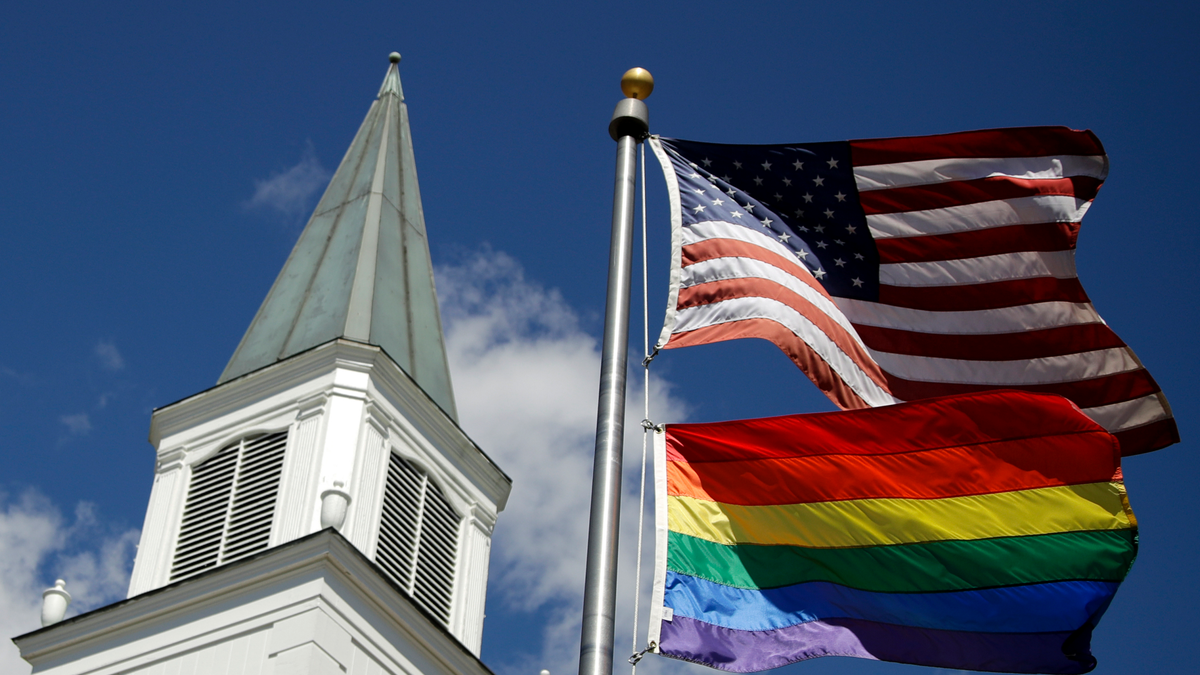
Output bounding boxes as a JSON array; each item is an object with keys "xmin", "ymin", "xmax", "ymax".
[{"xmin": 659, "ymin": 616, "xmax": 1096, "ymax": 673}]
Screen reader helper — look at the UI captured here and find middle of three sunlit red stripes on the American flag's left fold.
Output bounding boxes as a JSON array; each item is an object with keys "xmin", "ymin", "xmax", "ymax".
[{"xmin": 671, "ymin": 277, "xmax": 886, "ymax": 387}]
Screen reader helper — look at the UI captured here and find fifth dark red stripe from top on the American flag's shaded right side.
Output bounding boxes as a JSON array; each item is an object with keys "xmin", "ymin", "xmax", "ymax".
[{"xmin": 854, "ymin": 323, "xmax": 1126, "ymax": 362}]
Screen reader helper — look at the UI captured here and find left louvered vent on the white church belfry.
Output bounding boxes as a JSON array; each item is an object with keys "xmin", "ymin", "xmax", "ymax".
[{"xmin": 170, "ymin": 431, "xmax": 288, "ymax": 581}]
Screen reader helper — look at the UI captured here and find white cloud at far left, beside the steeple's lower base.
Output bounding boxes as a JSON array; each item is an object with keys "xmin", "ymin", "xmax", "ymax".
[{"xmin": 0, "ymin": 490, "xmax": 138, "ymax": 673}]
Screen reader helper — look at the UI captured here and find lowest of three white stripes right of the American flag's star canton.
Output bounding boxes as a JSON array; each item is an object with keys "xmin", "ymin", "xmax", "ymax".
[{"xmin": 880, "ymin": 251, "xmax": 1075, "ymax": 286}]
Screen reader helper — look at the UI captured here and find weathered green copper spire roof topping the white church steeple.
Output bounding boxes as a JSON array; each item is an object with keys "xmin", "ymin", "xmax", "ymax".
[{"xmin": 217, "ymin": 55, "xmax": 457, "ymax": 418}]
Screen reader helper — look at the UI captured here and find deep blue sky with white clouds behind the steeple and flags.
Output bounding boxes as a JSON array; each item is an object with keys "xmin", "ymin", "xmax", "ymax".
[{"xmin": 0, "ymin": 0, "xmax": 1200, "ymax": 675}]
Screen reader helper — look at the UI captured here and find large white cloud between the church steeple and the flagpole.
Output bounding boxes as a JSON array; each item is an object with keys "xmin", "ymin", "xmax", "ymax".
[{"xmin": 437, "ymin": 251, "xmax": 685, "ymax": 675}]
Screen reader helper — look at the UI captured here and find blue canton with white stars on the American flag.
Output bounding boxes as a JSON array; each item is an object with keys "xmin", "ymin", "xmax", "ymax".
[{"xmin": 660, "ymin": 138, "xmax": 880, "ymax": 300}]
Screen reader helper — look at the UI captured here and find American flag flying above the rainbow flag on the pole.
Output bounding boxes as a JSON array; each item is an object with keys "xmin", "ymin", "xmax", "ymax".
[{"xmin": 650, "ymin": 127, "xmax": 1178, "ymax": 455}]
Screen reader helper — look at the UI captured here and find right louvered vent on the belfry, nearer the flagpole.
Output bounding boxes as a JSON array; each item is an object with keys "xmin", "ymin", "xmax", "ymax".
[{"xmin": 376, "ymin": 453, "xmax": 460, "ymax": 625}]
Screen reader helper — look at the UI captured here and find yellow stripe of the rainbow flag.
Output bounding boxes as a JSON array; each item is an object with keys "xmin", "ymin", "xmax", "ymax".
[{"xmin": 667, "ymin": 483, "xmax": 1132, "ymax": 548}]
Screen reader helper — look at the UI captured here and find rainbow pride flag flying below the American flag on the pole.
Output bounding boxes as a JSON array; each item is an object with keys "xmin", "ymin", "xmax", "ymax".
[{"xmin": 649, "ymin": 392, "xmax": 1138, "ymax": 673}]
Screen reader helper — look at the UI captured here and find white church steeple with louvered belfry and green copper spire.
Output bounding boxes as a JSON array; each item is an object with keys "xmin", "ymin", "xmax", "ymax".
[{"xmin": 16, "ymin": 54, "xmax": 511, "ymax": 675}]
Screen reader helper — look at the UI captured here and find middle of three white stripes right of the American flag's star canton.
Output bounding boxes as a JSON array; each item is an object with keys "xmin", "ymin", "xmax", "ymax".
[{"xmin": 866, "ymin": 195, "xmax": 1091, "ymax": 239}]
